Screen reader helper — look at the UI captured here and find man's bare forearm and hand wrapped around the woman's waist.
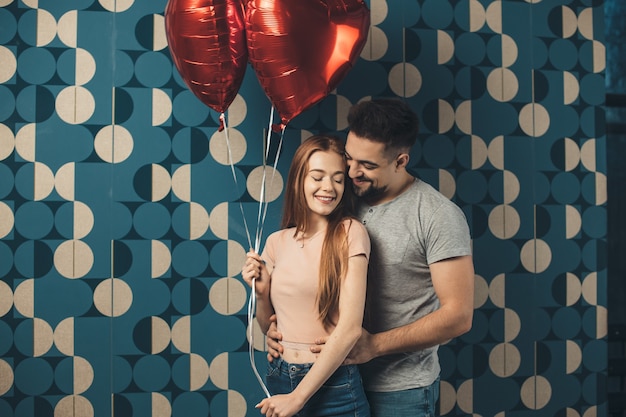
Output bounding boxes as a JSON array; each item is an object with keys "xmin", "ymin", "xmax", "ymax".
[{"xmin": 311, "ymin": 256, "xmax": 474, "ymax": 364}]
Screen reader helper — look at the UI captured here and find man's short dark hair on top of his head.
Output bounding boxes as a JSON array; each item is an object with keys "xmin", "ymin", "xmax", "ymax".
[{"xmin": 348, "ymin": 98, "xmax": 419, "ymax": 149}]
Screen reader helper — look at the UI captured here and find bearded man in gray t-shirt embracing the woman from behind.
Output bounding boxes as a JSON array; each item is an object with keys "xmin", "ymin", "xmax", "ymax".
[{"xmin": 268, "ymin": 99, "xmax": 474, "ymax": 417}]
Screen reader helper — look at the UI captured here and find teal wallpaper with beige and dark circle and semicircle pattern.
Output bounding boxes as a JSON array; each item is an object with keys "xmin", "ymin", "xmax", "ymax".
[{"xmin": 0, "ymin": 0, "xmax": 607, "ymax": 417}]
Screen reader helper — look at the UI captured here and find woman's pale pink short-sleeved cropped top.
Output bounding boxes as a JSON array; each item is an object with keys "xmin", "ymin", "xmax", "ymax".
[{"xmin": 262, "ymin": 220, "xmax": 370, "ymax": 350}]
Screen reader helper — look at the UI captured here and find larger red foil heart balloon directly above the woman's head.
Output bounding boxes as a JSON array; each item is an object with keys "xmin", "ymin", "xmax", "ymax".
[{"xmin": 245, "ymin": 0, "xmax": 370, "ymax": 127}]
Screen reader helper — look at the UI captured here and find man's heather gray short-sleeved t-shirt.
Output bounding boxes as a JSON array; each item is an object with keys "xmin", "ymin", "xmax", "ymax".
[{"xmin": 357, "ymin": 180, "xmax": 471, "ymax": 392}]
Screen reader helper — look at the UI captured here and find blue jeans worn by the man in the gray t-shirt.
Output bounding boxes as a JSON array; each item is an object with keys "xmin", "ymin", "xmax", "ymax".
[{"xmin": 365, "ymin": 379, "xmax": 439, "ymax": 417}]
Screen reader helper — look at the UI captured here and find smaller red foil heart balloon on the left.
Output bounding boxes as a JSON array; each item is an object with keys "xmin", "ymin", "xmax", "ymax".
[{"xmin": 165, "ymin": 0, "xmax": 248, "ymax": 118}]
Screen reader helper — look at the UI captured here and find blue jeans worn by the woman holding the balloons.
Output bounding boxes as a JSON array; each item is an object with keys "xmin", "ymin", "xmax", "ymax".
[{"xmin": 265, "ymin": 358, "xmax": 370, "ymax": 417}]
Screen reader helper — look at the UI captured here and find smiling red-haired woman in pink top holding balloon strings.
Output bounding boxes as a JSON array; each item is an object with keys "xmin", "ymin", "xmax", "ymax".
[{"xmin": 242, "ymin": 136, "xmax": 370, "ymax": 417}]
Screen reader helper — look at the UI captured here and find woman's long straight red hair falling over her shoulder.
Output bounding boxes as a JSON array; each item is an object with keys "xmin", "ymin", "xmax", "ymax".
[{"xmin": 281, "ymin": 135, "xmax": 354, "ymax": 327}]
